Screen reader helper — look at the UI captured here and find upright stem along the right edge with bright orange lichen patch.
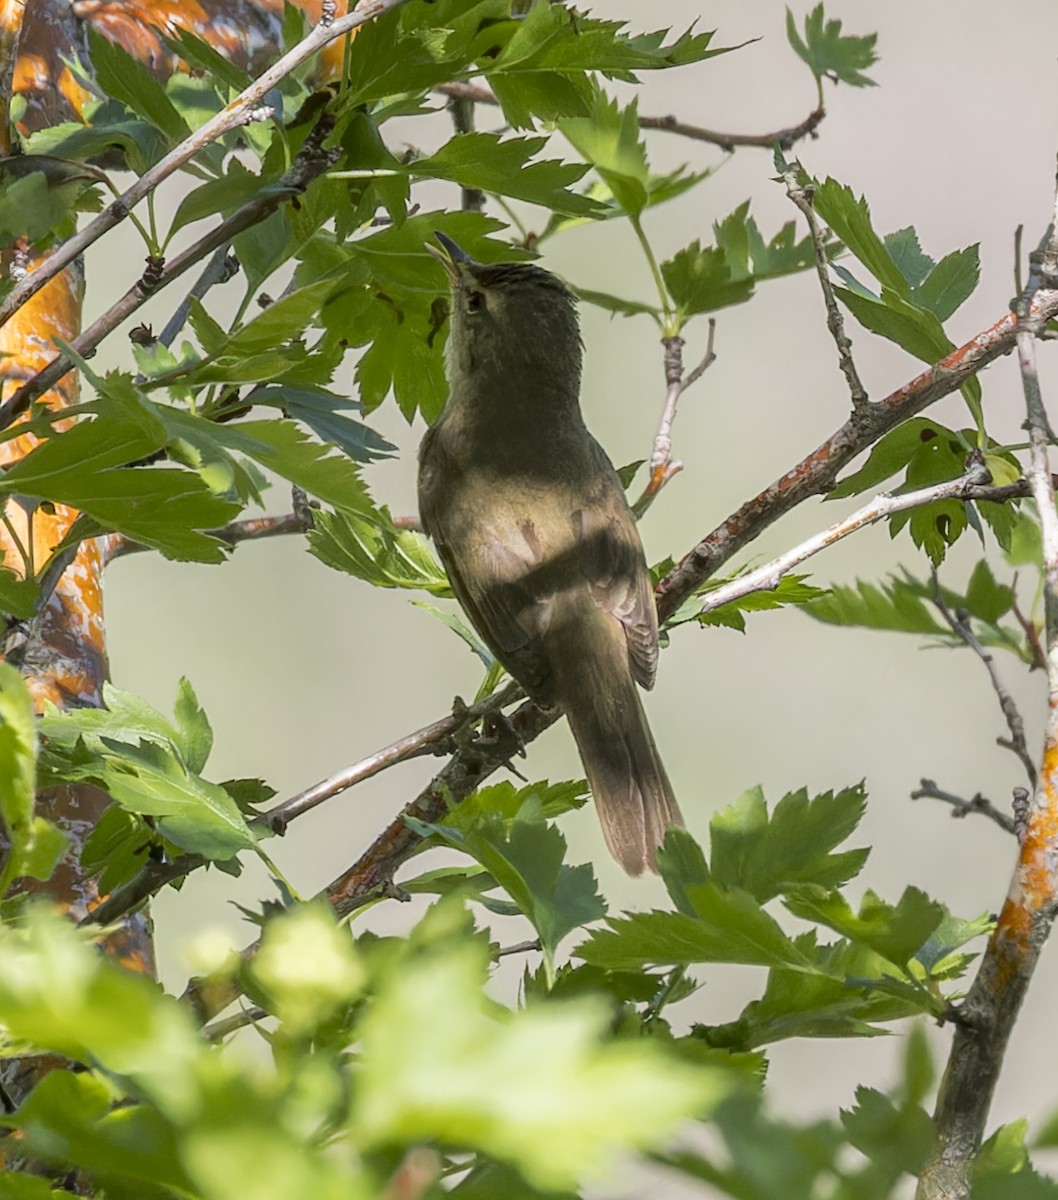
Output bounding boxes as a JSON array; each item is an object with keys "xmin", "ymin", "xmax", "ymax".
[{"xmin": 918, "ymin": 171, "xmax": 1058, "ymax": 1200}]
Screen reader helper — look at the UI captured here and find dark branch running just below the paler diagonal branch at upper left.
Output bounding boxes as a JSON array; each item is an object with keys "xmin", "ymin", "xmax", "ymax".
[{"xmin": 0, "ymin": 113, "xmax": 336, "ymax": 430}]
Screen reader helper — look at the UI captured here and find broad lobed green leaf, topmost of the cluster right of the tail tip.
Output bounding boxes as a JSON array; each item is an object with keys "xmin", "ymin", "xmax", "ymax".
[{"xmin": 709, "ymin": 786, "xmax": 868, "ymax": 904}]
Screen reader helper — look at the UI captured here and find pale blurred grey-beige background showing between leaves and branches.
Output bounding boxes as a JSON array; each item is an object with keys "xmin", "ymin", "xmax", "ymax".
[{"xmin": 88, "ymin": 0, "xmax": 1058, "ymax": 1198}]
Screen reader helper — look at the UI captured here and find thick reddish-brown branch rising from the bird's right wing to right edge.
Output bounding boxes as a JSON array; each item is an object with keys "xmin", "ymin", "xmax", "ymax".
[{"xmin": 656, "ymin": 288, "xmax": 1058, "ymax": 620}]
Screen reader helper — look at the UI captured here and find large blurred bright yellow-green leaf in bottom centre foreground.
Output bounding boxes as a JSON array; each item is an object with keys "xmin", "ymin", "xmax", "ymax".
[{"xmin": 353, "ymin": 916, "xmax": 737, "ymax": 1190}]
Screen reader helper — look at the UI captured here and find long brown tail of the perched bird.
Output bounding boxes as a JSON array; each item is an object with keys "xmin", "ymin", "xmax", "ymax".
[{"xmin": 548, "ymin": 610, "xmax": 684, "ymax": 875}]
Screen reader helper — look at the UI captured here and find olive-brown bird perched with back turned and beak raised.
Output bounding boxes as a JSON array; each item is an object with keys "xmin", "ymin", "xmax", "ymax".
[{"xmin": 419, "ymin": 233, "xmax": 684, "ymax": 875}]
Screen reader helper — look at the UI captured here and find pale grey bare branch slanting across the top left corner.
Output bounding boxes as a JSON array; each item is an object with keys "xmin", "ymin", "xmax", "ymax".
[{"xmin": 0, "ymin": 0, "xmax": 408, "ymax": 325}]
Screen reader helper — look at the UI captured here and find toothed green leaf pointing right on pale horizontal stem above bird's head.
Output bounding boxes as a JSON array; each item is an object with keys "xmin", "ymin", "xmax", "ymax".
[{"xmin": 408, "ymin": 132, "xmax": 599, "ymax": 216}]
